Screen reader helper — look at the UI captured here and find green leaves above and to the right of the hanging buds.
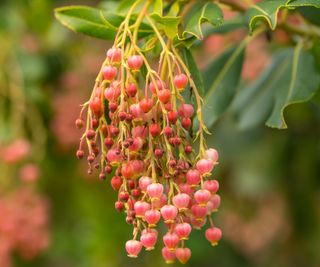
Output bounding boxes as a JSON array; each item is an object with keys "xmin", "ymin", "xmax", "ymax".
[{"xmin": 55, "ymin": 0, "xmax": 320, "ymax": 131}]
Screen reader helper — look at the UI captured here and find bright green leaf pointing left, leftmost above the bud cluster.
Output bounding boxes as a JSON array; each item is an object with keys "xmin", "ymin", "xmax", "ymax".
[{"xmin": 55, "ymin": 6, "xmax": 122, "ymax": 40}]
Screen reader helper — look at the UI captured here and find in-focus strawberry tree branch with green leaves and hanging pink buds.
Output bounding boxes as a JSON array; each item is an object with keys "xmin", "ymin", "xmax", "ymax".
[{"xmin": 55, "ymin": 0, "xmax": 320, "ymax": 263}]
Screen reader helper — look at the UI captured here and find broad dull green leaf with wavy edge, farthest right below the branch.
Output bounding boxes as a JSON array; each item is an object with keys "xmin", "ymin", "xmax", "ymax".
[{"xmin": 233, "ymin": 45, "xmax": 320, "ymax": 129}]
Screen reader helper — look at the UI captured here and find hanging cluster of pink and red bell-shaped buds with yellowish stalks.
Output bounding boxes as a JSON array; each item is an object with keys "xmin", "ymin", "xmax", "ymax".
[{"xmin": 76, "ymin": 3, "xmax": 221, "ymax": 263}]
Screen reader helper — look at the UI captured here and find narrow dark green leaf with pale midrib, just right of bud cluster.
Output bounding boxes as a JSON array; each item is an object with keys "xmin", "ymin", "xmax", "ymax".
[{"xmin": 203, "ymin": 43, "xmax": 247, "ymax": 128}]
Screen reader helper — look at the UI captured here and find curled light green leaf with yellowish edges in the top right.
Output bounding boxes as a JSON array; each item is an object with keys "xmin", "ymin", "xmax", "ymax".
[{"xmin": 245, "ymin": 0, "xmax": 320, "ymax": 32}]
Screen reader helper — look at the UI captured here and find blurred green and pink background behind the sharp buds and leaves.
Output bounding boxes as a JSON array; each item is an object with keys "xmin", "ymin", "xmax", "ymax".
[{"xmin": 0, "ymin": 0, "xmax": 320, "ymax": 267}]
